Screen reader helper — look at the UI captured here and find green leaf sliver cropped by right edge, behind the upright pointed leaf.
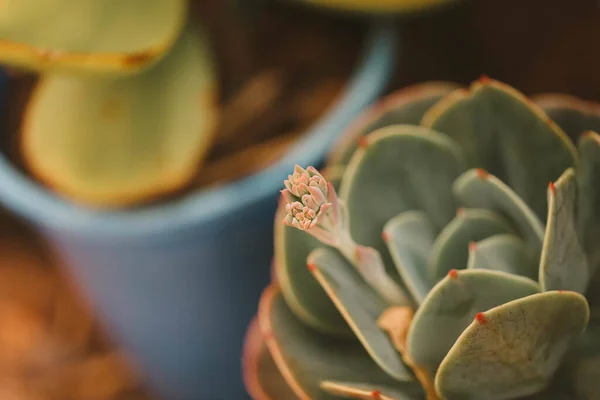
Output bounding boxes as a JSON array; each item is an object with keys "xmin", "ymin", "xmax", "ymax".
[{"xmin": 577, "ymin": 131, "xmax": 600, "ymax": 278}]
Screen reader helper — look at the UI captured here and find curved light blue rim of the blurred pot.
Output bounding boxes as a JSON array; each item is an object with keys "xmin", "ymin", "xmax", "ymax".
[{"xmin": 0, "ymin": 18, "xmax": 396, "ymax": 240}]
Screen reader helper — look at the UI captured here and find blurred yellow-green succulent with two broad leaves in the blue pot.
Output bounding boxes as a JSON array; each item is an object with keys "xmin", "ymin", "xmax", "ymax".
[{"xmin": 0, "ymin": 0, "xmax": 219, "ymax": 207}]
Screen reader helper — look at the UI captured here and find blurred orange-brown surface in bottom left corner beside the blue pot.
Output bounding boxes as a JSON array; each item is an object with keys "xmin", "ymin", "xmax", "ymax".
[{"xmin": 0, "ymin": 212, "xmax": 150, "ymax": 400}]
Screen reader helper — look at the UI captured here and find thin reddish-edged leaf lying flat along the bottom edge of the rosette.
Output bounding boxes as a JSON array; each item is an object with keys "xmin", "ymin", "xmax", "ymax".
[{"xmin": 321, "ymin": 381, "xmax": 423, "ymax": 400}]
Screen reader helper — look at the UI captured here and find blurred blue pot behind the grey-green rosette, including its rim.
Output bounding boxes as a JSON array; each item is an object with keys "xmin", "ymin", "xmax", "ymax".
[{"xmin": 0, "ymin": 21, "xmax": 395, "ymax": 400}]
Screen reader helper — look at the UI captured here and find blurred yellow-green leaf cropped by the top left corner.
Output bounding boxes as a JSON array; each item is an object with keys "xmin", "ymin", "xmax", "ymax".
[{"xmin": 0, "ymin": 0, "xmax": 188, "ymax": 73}]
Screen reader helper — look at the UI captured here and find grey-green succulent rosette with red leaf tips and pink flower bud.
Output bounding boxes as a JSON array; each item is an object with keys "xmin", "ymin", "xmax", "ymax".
[{"xmin": 244, "ymin": 77, "xmax": 600, "ymax": 400}]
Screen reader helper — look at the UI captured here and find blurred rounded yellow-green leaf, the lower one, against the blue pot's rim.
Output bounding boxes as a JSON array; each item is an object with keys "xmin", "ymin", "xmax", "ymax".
[{"xmin": 21, "ymin": 23, "xmax": 217, "ymax": 207}]
